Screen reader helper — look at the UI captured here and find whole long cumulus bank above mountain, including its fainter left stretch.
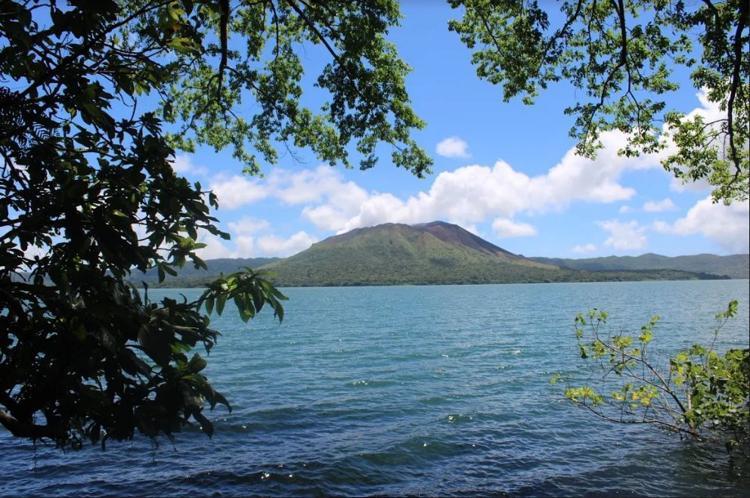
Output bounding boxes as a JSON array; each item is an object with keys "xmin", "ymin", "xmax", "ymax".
[{"xmin": 211, "ymin": 127, "xmax": 658, "ymax": 236}]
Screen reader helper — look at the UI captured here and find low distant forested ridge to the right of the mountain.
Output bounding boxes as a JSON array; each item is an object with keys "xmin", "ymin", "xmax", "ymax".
[{"xmin": 530, "ymin": 253, "xmax": 750, "ymax": 278}]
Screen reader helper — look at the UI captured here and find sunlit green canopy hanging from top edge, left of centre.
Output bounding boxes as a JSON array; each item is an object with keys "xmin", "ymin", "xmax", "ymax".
[{"xmin": 151, "ymin": 0, "xmax": 430, "ymax": 176}]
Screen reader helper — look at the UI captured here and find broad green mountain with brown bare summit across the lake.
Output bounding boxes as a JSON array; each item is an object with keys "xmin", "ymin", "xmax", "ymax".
[{"xmin": 264, "ymin": 222, "xmax": 724, "ymax": 286}]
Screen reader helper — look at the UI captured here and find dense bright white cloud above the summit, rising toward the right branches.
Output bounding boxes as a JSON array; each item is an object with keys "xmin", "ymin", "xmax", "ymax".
[{"xmin": 334, "ymin": 126, "xmax": 659, "ymax": 233}]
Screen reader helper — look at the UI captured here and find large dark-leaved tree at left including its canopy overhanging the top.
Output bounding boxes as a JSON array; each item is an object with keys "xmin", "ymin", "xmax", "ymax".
[{"xmin": 0, "ymin": 0, "xmax": 430, "ymax": 447}]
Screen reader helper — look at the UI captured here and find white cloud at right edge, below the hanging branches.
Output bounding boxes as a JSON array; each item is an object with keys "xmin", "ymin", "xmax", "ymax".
[{"xmin": 653, "ymin": 196, "xmax": 750, "ymax": 253}]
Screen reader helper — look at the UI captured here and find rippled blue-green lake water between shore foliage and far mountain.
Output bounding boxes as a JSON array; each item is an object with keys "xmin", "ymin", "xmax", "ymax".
[{"xmin": 0, "ymin": 280, "xmax": 750, "ymax": 496}]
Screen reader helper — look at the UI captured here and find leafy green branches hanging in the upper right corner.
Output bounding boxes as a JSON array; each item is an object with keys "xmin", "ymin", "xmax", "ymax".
[{"xmin": 449, "ymin": 0, "xmax": 750, "ymax": 202}]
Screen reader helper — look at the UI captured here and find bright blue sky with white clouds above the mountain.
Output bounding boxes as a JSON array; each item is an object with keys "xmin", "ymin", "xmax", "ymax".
[{"xmin": 174, "ymin": 1, "xmax": 748, "ymax": 259}]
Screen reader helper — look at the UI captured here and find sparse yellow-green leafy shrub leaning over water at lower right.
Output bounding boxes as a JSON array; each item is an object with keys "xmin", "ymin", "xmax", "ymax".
[{"xmin": 553, "ymin": 301, "xmax": 750, "ymax": 453}]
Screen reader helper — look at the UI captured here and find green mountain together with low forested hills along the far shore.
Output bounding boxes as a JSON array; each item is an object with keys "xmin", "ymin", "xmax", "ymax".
[{"xmin": 132, "ymin": 221, "xmax": 748, "ymax": 287}]
